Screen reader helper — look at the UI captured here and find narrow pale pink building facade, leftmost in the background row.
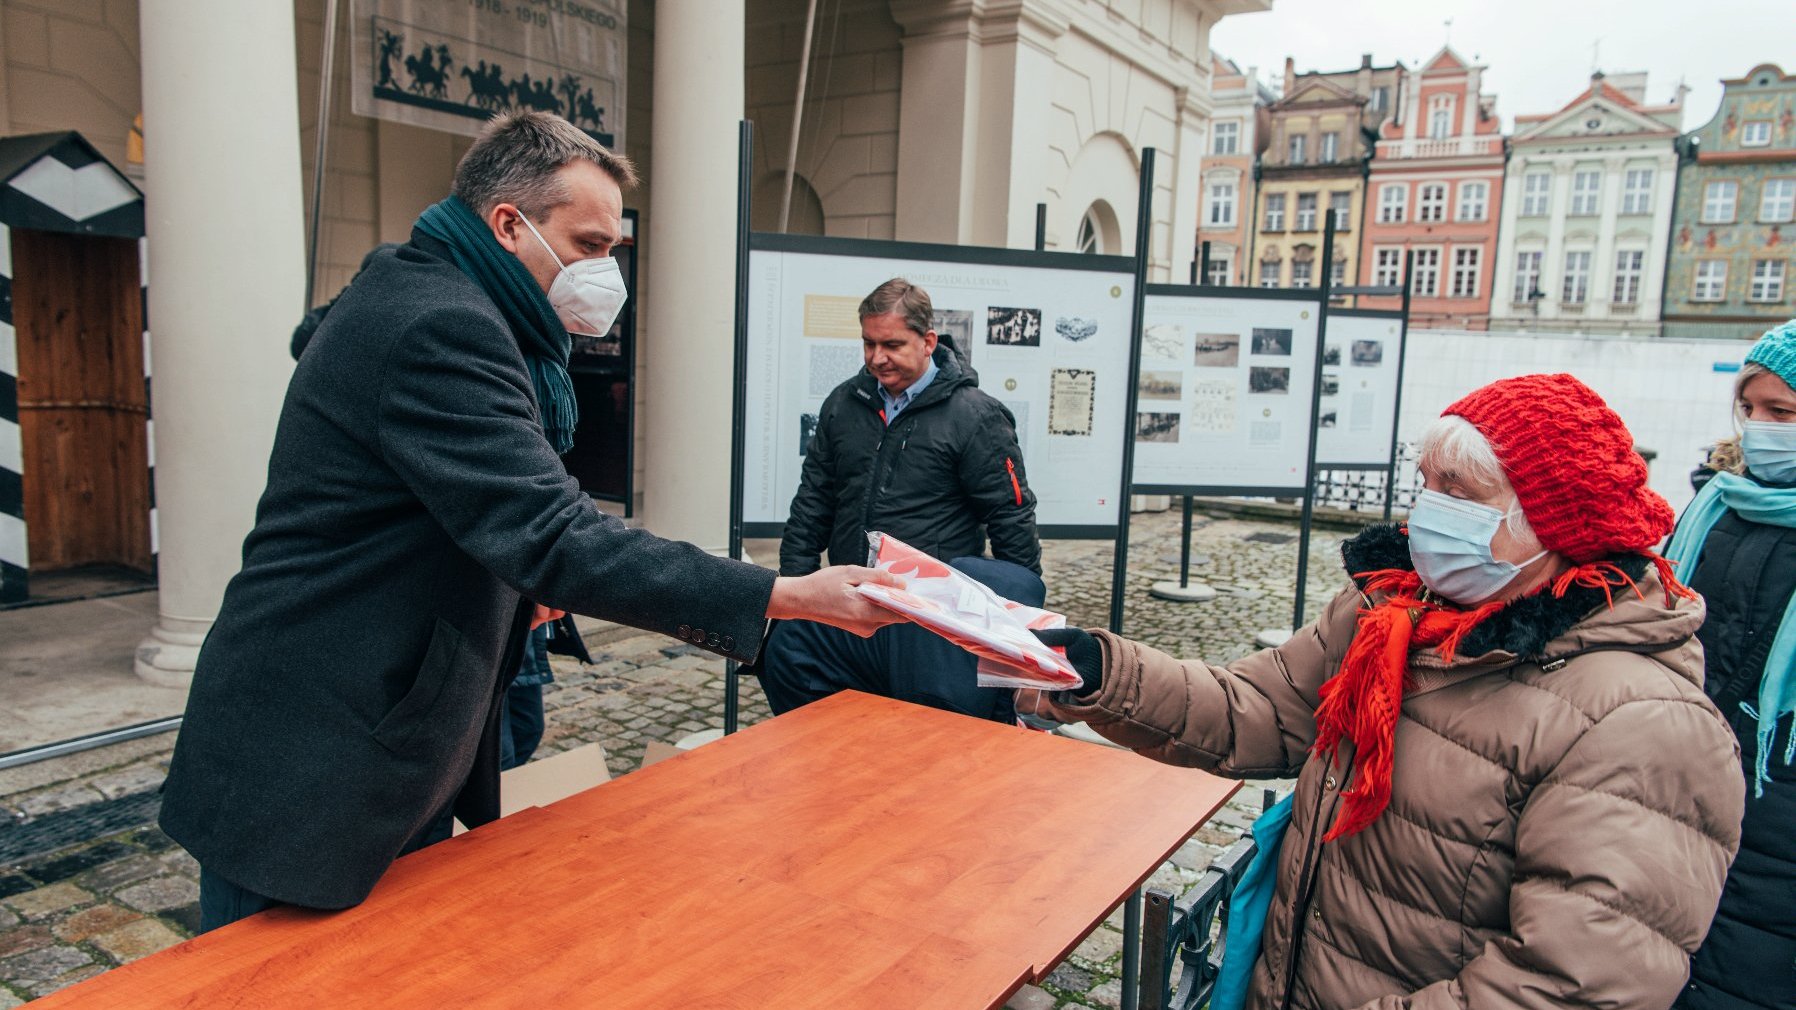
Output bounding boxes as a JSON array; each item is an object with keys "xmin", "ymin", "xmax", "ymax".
[{"xmin": 1198, "ymin": 52, "xmax": 1277, "ymax": 284}]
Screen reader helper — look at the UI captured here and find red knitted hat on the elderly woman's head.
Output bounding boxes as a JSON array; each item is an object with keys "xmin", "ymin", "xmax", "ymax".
[{"xmin": 1440, "ymin": 374, "xmax": 1676, "ymax": 564}]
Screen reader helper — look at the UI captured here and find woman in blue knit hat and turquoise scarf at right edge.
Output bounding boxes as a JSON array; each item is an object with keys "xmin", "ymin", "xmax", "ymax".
[{"xmin": 1665, "ymin": 320, "xmax": 1796, "ymax": 1010}]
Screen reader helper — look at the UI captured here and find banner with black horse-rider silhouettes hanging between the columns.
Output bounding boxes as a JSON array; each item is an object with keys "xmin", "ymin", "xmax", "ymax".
[{"xmin": 348, "ymin": 0, "xmax": 627, "ymax": 149}]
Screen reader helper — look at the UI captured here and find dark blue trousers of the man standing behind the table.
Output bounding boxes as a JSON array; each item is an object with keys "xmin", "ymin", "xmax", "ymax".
[{"xmin": 762, "ymin": 557, "xmax": 1047, "ymax": 722}]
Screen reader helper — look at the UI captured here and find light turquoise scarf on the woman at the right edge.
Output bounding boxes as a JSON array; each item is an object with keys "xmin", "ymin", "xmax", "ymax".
[{"xmin": 1665, "ymin": 473, "xmax": 1796, "ymax": 796}]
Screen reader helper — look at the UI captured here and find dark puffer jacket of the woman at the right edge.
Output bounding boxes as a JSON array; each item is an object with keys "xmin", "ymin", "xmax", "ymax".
[{"xmin": 1677, "ymin": 512, "xmax": 1796, "ymax": 1010}]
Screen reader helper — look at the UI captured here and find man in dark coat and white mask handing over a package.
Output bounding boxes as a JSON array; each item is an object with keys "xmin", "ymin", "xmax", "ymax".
[{"xmin": 162, "ymin": 113, "xmax": 891, "ymax": 929}]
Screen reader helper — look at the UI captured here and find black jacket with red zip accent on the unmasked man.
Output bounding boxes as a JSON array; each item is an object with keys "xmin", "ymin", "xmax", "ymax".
[{"xmin": 779, "ymin": 341, "xmax": 1042, "ymax": 575}]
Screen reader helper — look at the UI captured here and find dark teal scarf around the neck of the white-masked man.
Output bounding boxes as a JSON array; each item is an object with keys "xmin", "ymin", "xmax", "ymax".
[{"xmin": 417, "ymin": 196, "xmax": 580, "ymax": 453}]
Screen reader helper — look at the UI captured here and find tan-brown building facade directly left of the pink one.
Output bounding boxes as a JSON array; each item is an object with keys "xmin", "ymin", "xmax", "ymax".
[{"xmin": 1246, "ymin": 56, "xmax": 1408, "ymax": 288}]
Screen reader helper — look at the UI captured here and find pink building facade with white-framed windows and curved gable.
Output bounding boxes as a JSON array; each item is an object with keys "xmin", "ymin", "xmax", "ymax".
[{"xmin": 1358, "ymin": 49, "xmax": 1505, "ymax": 329}]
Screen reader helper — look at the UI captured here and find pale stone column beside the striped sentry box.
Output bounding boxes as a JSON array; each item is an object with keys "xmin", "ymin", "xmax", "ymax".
[{"xmin": 136, "ymin": 0, "xmax": 305, "ymax": 687}]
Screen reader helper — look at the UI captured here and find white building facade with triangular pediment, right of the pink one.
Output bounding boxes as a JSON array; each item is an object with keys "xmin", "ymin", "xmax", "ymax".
[{"xmin": 1491, "ymin": 72, "xmax": 1683, "ymax": 334}]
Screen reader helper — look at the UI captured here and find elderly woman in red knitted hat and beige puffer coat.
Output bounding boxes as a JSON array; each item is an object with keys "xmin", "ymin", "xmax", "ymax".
[{"xmin": 1018, "ymin": 376, "xmax": 1746, "ymax": 1010}]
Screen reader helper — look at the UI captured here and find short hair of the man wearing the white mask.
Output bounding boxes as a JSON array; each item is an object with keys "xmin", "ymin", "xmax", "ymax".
[{"xmin": 451, "ymin": 111, "xmax": 636, "ymax": 221}]
